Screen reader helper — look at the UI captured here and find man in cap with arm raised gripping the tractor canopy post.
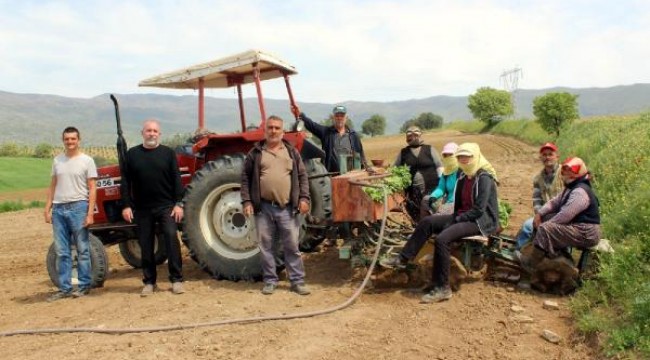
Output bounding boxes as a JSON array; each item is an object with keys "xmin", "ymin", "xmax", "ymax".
[{"xmin": 291, "ymin": 105, "xmax": 371, "ymax": 172}]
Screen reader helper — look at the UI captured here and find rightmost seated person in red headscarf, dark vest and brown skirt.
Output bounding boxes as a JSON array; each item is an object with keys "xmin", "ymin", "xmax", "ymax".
[{"xmin": 520, "ymin": 157, "xmax": 600, "ymax": 272}]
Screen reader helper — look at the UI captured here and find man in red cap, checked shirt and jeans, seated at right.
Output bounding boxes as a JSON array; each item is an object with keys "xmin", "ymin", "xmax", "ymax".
[{"xmin": 515, "ymin": 142, "xmax": 563, "ymax": 250}]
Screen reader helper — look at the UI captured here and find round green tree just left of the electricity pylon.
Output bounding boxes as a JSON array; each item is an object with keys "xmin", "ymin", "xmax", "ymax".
[{"xmin": 467, "ymin": 87, "xmax": 514, "ymax": 126}]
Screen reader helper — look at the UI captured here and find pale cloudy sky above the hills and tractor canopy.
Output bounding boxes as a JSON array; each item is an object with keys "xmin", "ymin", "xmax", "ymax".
[{"xmin": 0, "ymin": 0, "xmax": 650, "ymax": 103}]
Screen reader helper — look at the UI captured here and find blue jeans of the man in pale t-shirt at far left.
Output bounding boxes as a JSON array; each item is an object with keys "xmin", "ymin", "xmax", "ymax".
[{"xmin": 52, "ymin": 200, "xmax": 92, "ymax": 293}]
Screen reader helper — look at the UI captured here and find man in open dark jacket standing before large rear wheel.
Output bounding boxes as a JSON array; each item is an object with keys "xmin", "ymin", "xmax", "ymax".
[{"xmin": 241, "ymin": 116, "xmax": 311, "ymax": 295}]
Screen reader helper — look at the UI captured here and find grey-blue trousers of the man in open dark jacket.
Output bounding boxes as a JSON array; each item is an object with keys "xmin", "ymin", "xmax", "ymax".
[{"xmin": 255, "ymin": 201, "xmax": 305, "ymax": 284}]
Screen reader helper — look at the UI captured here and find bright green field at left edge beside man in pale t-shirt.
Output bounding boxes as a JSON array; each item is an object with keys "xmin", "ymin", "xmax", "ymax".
[{"xmin": 0, "ymin": 157, "xmax": 52, "ymax": 192}]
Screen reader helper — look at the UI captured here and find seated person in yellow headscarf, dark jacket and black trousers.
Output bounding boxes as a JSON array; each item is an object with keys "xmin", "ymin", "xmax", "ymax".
[{"xmin": 381, "ymin": 143, "xmax": 499, "ymax": 303}]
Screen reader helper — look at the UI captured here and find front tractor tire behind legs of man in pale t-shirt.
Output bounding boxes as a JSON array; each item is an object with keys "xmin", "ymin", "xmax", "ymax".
[{"xmin": 45, "ymin": 234, "xmax": 108, "ymax": 288}]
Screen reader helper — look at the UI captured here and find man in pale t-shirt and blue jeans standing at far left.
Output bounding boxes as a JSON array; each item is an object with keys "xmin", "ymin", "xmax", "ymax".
[{"xmin": 45, "ymin": 126, "xmax": 97, "ymax": 302}]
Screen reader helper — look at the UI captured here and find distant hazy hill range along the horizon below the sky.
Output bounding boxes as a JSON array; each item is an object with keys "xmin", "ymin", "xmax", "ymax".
[{"xmin": 0, "ymin": 84, "xmax": 650, "ymax": 145}]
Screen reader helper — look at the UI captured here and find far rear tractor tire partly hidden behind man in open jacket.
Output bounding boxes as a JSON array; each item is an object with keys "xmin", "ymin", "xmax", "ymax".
[{"xmin": 298, "ymin": 159, "xmax": 332, "ymax": 252}]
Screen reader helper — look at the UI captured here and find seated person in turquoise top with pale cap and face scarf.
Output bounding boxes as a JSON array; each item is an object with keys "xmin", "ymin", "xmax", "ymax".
[{"xmin": 420, "ymin": 142, "xmax": 462, "ymax": 219}]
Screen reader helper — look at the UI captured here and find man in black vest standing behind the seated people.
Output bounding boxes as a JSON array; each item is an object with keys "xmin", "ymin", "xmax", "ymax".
[{"xmin": 394, "ymin": 126, "xmax": 443, "ymax": 222}]
